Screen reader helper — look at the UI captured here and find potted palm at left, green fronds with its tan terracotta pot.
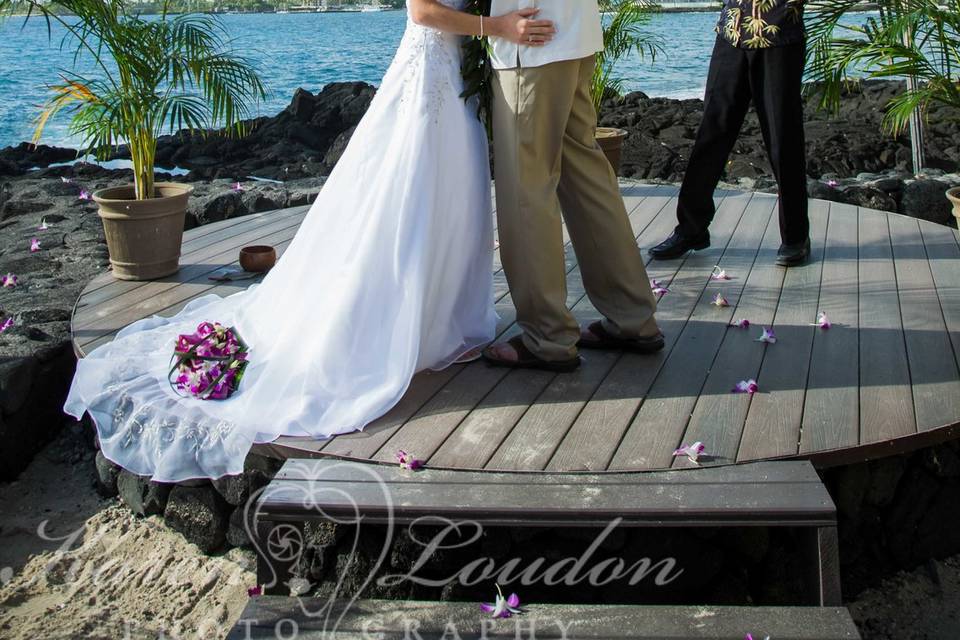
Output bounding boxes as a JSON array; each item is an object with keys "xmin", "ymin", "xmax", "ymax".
[{"xmin": 0, "ymin": 0, "xmax": 265, "ymax": 280}]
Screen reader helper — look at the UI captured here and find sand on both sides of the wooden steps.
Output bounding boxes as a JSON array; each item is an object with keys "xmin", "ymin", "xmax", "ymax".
[{"xmin": 0, "ymin": 433, "xmax": 960, "ymax": 640}]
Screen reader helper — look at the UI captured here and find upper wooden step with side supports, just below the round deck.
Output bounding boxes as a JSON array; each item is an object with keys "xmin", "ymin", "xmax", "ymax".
[{"xmin": 249, "ymin": 459, "xmax": 841, "ymax": 606}]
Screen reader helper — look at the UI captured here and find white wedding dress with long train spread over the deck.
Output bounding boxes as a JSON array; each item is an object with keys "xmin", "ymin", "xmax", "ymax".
[{"xmin": 64, "ymin": 0, "xmax": 497, "ymax": 482}]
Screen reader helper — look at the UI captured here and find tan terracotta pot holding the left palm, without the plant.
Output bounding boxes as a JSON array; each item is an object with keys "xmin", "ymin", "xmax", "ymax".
[{"xmin": 93, "ymin": 182, "xmax": 193, "ymax": 280}]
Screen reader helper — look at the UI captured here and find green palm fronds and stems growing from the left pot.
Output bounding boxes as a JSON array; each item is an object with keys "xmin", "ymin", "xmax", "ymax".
[{"xmin": 0, "ymin": 0, "xmax": 265, "ymax": 200}]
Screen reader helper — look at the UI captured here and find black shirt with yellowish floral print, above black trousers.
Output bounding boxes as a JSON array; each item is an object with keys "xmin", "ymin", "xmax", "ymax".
[{"xmin": 717, "ymin": 0, "xmax": 806, "ymax": 49}]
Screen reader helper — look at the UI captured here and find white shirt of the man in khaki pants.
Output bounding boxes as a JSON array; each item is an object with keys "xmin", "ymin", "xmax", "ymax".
[{"xmin": 490, "ymin": 0, "xmax": 603, "ymax": 69}]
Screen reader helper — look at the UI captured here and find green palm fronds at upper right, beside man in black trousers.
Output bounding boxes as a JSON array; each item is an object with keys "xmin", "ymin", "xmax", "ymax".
[{"xmin": 807, "ymin": 0, "xmax": 960, "ymax": 134}]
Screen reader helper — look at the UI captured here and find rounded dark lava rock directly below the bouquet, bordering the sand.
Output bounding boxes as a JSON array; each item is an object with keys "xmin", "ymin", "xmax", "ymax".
[{"xmin": 163, "ymin": 485, "xmax": 230, "ymax": 553}]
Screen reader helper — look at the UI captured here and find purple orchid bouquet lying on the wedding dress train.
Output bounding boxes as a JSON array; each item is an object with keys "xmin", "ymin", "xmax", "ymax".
[{"xmin": 168, "ymin": 322, "xmax": 250, "ymax": 400}]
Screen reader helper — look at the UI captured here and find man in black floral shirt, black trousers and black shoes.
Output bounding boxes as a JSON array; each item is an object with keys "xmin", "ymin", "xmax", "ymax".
[{"xmin": 650, "ymin": 0, "xmax": 810, "ymax": 267}]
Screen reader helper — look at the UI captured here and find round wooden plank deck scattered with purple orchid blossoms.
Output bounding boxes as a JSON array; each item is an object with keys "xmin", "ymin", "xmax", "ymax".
[{"xmin": 73, "ymin": 186, "xmax": 960, "ymax": 471}]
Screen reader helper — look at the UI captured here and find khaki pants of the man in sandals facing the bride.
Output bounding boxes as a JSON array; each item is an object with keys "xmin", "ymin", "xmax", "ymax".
[{"xmin": 493, "ymin": 56, "xmax": 659, "ymax": 360}]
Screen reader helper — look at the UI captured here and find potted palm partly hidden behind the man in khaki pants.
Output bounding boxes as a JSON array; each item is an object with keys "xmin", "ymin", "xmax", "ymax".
[{"xmin": 591, "ymin": 0, "xmax": 663, "ymax": 173}]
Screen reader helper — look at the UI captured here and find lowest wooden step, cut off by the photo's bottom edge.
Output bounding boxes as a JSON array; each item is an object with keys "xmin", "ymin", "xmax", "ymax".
[{"xmin": 227, "ymin": 596, "xmax": 860, "ymax": 640}]
